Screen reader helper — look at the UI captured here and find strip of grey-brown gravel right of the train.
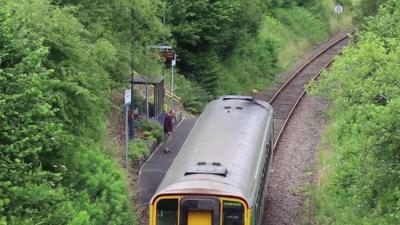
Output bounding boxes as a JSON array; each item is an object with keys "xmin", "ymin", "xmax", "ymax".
[{"xmin": 263, "ymin": 96, "xmax": 327, "ymax": 225}]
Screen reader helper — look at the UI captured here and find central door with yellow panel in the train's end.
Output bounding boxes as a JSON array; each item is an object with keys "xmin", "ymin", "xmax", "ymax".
[{"xmin": 180, "ymin": 196, "xmax": 220, "ymax": 225}]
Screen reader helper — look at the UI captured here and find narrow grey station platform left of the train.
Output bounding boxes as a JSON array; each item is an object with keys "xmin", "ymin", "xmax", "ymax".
[{"xmin": 137, "ymin": 117, "xmax": 197, "ymax": 206}]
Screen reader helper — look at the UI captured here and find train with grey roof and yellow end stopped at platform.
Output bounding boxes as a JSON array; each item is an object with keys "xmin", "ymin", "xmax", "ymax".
[{"xmin": 149, "ymin": 95, "xmax": 274, "ymax": 225}]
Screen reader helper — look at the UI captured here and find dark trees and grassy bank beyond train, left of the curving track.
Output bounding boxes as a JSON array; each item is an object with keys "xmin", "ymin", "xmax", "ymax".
[{"xmin": 167, "ymin": 0, "xmax": 348, "ymax": 99}]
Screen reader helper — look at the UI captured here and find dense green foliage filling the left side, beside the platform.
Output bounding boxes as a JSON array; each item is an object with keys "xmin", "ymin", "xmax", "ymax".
[{"xmin": 0, "ymin": 0, "xmax": 134, "ymax": 225}]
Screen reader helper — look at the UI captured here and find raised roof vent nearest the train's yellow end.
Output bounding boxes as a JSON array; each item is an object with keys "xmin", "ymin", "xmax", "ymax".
[{"xmin": 185, "ymin": 162, "xmax": 228, "ymax": 177}]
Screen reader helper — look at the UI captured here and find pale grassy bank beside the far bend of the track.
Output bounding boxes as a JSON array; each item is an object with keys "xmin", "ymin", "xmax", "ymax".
[{"xmin": 260, "ymin": 0, "xmax": 352, "ymax": 70}]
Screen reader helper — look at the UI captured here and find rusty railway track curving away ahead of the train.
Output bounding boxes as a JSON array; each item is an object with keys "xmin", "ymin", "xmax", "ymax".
[{"xmin": 269, "ymin": 35, "xmax": 350, "ymax": 149}]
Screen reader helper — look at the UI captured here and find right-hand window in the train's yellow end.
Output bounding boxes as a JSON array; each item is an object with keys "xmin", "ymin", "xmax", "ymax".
[{"xmin": 222, "ymin": 201, "xmax": 244, "ymax": 225}]
